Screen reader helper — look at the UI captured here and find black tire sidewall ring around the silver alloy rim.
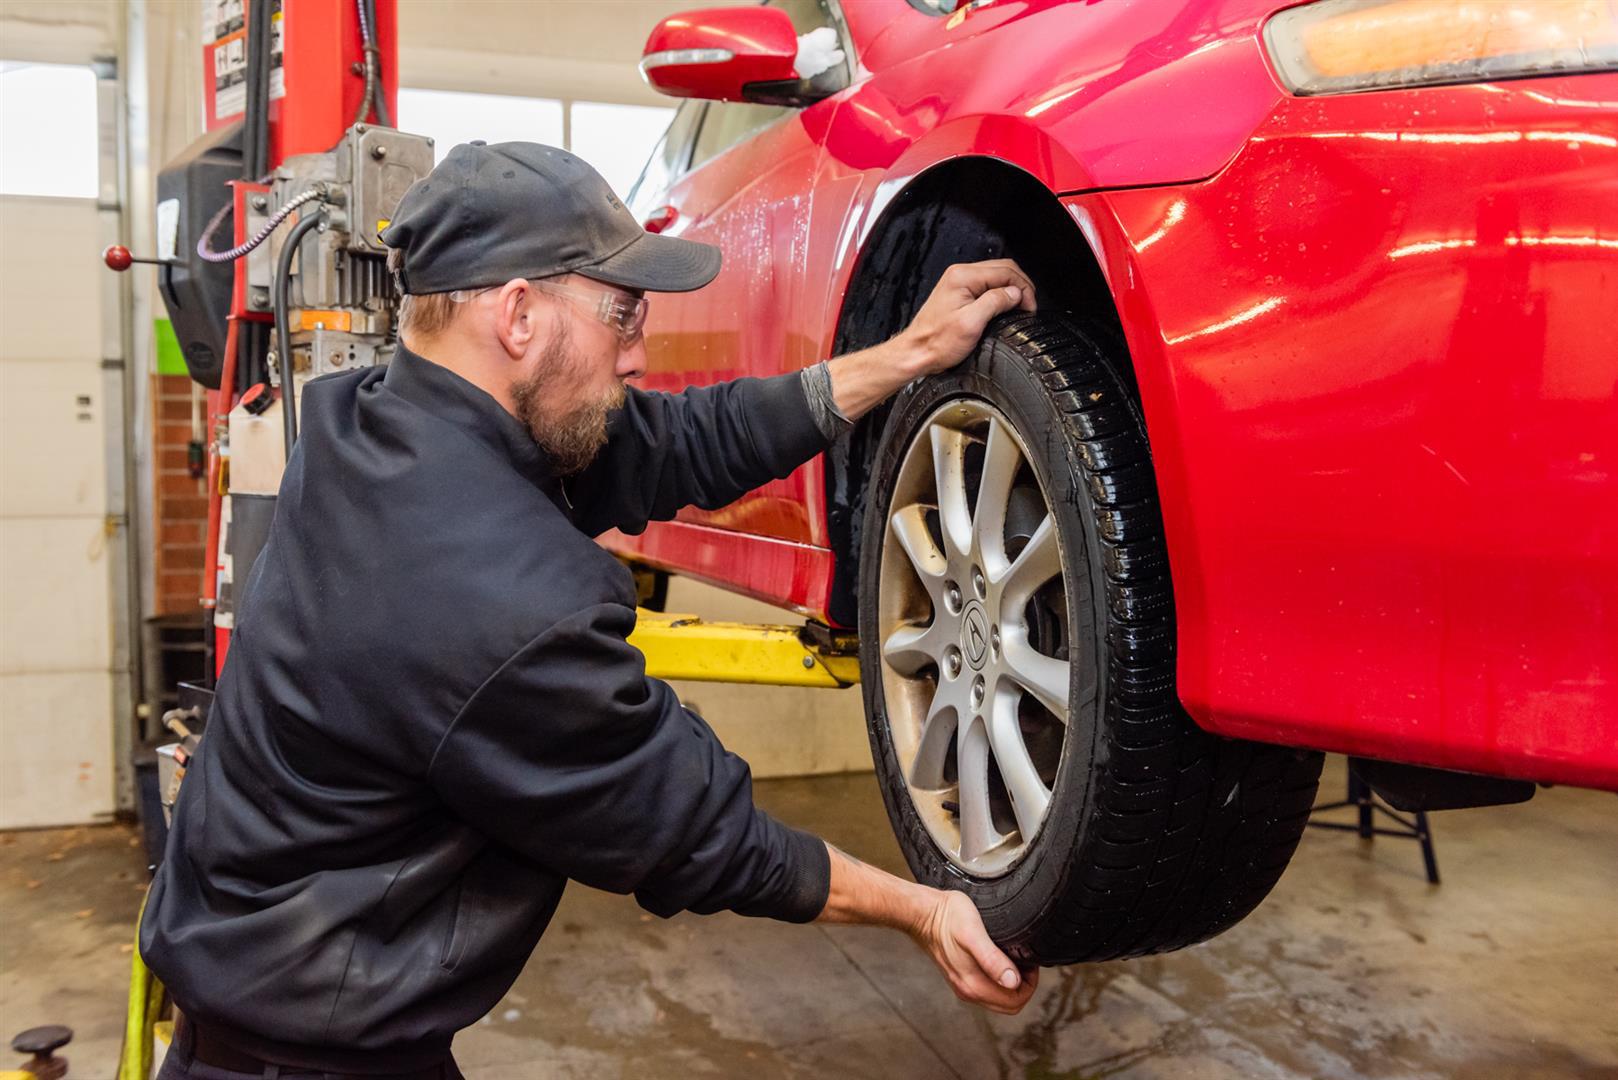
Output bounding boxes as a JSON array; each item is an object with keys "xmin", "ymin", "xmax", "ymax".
[{"xmin": 859, "ymin": 332, "xmax": 1107, "ymax": 952}]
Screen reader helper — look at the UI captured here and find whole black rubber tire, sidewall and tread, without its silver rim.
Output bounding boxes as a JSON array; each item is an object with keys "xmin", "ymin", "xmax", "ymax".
[{"xmin": 859, "ymin": 314, "xmax": 1322, "ymax": 963}]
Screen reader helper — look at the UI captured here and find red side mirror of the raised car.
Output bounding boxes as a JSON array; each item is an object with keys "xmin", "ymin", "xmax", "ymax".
[{"xmin": 641, "ymin": 6, "xmax": 840, "ymax": 104}]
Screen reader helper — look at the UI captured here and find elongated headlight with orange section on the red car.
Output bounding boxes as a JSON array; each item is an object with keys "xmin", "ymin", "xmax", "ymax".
[{"xmin": 1264, "ymin": 0, "xmax": 1618, "ymax": 94}]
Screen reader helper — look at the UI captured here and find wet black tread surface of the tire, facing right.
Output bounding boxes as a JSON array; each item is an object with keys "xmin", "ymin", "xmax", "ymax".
[{"xmin": 990, "ymin": 316, "xmax": 1322, "ymax": 963}]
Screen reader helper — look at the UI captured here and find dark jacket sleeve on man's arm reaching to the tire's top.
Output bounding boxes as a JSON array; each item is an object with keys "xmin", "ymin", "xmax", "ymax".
[{"xmin": 566, "ymin": 372, "xmax": 827, "ymax": 536}]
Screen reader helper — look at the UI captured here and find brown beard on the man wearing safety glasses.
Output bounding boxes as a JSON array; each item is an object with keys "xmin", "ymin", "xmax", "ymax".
[{"xmin": 511, "ymin": 324, "xmax": 625, "ymax": 476}]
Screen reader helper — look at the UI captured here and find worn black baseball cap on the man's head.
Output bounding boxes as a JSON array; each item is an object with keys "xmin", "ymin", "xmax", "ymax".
[{"xmin": 382, "ymin": 141, "xmax": 720, "ymax": 295}]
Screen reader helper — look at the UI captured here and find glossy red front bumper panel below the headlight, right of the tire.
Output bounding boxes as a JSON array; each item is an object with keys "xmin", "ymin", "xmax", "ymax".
[{"xmin": 1068, "ymin": 76, "xmax": 1618, "ymax": 787}]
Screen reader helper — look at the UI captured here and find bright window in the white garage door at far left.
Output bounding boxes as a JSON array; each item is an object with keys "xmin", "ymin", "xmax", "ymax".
[{"xmin": 0, "ymin": 60, "xmax": 100, "ymax": 199}]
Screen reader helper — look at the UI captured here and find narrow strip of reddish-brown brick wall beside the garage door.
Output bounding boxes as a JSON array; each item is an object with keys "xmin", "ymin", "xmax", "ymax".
[{"xmin": 152, "ymin": 376, "xmax": 207, "ymax": 615}]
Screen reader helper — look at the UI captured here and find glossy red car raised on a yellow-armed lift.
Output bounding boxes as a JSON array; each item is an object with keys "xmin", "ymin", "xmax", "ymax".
[{"xmin": 607, "ymin": 0, "xmax": 1618, "ymax": 962}]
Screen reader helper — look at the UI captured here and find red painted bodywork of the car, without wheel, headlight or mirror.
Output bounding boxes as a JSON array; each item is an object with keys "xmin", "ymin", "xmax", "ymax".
[{"xmin": 607, "ymin": 0, "xmax": 1618, "ymax": 789}]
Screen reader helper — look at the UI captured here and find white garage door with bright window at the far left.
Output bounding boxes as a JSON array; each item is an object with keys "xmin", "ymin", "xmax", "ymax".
[{"xmin": 0, "ymin": 65, "xmax": 120, "ymax": 827}]
